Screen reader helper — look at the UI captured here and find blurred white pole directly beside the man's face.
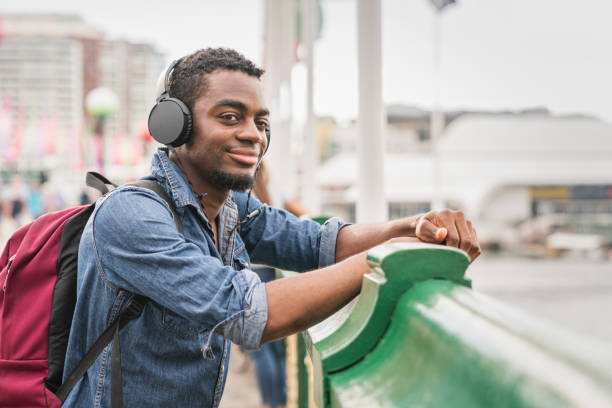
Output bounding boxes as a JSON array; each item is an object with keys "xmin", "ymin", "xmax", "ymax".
[{"xmin": 263, "ymin": 0, "xmax": 297, "ymax": 202}]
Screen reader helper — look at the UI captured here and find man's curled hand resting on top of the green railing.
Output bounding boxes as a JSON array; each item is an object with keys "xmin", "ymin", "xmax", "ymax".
[{"xmin": 415, "ymin": 209, "xmax": 480, "ymax": 261}]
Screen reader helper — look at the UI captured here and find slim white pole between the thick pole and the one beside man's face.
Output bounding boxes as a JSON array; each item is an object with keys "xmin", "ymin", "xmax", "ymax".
[{"xmin": 301, "ymin": 0, "xmax": 321, "ymax": 215}]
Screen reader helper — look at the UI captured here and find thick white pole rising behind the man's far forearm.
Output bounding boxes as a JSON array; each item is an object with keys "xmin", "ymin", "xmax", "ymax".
[{"xmin": 356, "ymin": 0, "xmax": 388, "ymax": 222}]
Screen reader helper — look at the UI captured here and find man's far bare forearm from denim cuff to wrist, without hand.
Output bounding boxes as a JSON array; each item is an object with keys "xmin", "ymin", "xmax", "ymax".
[{"xmin": 336, "ymin": 215, "xmax": 421, "ymax": 262}]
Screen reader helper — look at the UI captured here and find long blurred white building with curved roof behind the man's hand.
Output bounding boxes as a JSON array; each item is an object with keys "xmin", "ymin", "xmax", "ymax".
[{"xmin": 317, "ymin": 106, "xmax": 612, "ymax": 253}]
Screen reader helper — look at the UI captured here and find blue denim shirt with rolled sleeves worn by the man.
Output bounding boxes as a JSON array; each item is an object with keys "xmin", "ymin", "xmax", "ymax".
[{"xmin": 64, "ymin": 148, "xmax": 344, "ymax": 408}]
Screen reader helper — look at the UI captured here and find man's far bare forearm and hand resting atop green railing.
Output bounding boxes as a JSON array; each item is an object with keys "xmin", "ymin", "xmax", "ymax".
[{"xmin": 336, "ymin": 210, "xmax": 480, "ymax": 262}]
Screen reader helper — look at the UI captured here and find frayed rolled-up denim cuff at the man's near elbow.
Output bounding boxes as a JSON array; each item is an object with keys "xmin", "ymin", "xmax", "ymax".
[{"xmin": 216, "ymin": 269, "xmax": 268, "ymax": 350}]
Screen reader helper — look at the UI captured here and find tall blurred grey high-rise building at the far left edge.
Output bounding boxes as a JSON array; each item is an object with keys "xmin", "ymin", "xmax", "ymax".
[{"xmin": 0, "ymin": 14, "xmax": 99, "ymax": 170}]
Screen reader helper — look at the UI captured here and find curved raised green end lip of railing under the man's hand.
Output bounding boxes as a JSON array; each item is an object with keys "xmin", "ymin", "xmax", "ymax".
[{"xmin": 304, "ymin": 243, "xmax": 469, "ymax": 406}]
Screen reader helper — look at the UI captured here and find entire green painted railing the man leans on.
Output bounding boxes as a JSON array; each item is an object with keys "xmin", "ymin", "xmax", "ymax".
[{"xmin": 280, "ymin": 244, "xmax": 612, "ymax": 408}]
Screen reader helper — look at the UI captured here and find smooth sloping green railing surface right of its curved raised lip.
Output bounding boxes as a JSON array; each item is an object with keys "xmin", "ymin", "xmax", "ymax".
[{"xmin": 328, "ymin": 280, "xmax": 612, "ymax": 408}]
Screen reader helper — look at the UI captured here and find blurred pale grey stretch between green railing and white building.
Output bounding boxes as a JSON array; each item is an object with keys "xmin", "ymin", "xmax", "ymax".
[{"xmin": 467, "ymin": 256, "xmax": 612, "ymax": 343}]
